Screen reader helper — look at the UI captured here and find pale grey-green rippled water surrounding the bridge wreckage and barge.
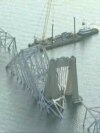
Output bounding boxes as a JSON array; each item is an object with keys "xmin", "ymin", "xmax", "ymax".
[{"xmin": 0, "ymin": 0, "xmax": 100, "ymax": 133}]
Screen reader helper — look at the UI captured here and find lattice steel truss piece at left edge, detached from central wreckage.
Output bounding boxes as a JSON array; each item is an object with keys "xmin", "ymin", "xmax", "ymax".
[{"xmin": 0, "ymin": 28, "xmax": 17, "ymax": 56}]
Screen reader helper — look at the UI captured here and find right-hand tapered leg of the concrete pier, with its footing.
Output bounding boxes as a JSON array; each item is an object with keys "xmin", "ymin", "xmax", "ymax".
[{"xmin": 66, "ymin": 56, "xmax": 82, "ymax": 103}]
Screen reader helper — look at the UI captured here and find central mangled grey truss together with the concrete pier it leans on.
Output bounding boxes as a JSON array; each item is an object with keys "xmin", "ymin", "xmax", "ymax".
[{"xmin": 6, "ymin": 45, "xmax": 82, "ymax": 118}]
